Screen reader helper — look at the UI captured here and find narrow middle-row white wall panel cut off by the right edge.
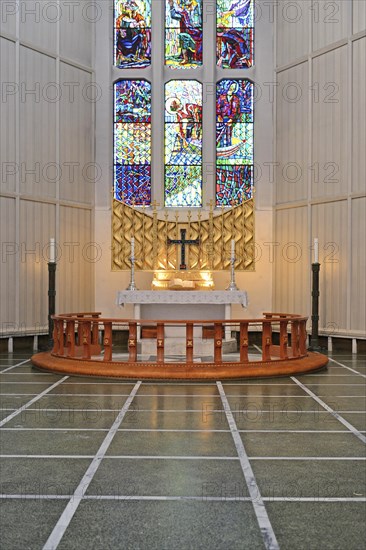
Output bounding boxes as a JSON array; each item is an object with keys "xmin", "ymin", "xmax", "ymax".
[{"xmin": 352, "ymin": 38, "xmax": 366, "ymax": 196}]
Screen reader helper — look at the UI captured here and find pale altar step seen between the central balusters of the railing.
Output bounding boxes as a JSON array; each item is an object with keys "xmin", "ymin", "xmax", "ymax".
[{"xmin": 137, "ymin": 337, "xmax": 238, "ymax": 356}]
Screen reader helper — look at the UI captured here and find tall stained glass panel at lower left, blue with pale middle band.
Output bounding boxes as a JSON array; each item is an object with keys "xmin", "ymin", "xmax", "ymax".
[{"xmin": 114, "ymin": 80, "xmax": 151, "ymax": 205}]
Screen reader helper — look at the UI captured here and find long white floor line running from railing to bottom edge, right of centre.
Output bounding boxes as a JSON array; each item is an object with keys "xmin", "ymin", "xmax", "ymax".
[{"xmin": 216, "ymin": 382, "xmax": 279, "ymax": 550}]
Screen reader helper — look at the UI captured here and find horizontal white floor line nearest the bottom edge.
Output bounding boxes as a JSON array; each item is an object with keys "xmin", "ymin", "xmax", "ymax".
[{"xmin": 0, "ymin": 494, "xmax": 366, "ymax": 502}]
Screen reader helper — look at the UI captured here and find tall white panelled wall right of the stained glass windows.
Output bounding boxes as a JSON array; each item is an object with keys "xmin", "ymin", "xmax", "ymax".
[{"xmin": 273, "ymin": 0, "xmax": 366, "ymax": 337}]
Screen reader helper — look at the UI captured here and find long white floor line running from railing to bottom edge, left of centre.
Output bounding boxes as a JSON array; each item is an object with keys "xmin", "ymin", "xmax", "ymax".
[{"xmin": 43, "ymin": 381, "xmax": 141, "ymax": 550}]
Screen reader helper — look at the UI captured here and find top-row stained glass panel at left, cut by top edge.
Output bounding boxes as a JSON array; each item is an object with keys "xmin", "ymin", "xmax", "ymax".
[{"xmin": 114, "ymin": 0, "xmax": 151, "ymax": 69}]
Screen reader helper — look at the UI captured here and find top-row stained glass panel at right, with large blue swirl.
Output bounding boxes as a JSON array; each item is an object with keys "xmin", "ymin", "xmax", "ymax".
[{"xmin": 216, "ymin": 0, "xmax": 254, "ymax": 69}]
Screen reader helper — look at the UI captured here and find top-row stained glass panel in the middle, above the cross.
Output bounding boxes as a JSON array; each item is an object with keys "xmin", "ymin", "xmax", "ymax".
[{"xmin": 165, "ymin": 0, "xmax": 202, "ymax": 69}]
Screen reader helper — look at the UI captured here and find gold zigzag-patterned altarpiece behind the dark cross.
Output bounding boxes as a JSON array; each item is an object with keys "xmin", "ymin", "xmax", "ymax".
[{"xmin": 112, "ymin": 199, "xmax": 255, "ymax": 290}]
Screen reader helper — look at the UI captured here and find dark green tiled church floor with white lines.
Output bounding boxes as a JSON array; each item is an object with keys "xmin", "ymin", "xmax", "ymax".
[{"xmin": 0, "ymin": 349, "xmax": 366, "ymax": 550}]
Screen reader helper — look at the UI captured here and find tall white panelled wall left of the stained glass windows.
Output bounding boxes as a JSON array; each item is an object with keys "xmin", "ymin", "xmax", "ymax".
[{"xmin": 0, "ymin": 0, "xmax": 97, "ymax": 337}]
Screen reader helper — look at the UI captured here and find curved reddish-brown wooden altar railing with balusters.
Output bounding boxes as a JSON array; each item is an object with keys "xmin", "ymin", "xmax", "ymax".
[{"xmin": 52, "ymin": 312, "xmax": 308, "ymax": 364}]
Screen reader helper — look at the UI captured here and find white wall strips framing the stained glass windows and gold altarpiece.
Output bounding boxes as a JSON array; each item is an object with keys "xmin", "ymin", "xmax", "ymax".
[{"xmin": 95, "ymin": 0, "xmax": 274, "ymax": 317}]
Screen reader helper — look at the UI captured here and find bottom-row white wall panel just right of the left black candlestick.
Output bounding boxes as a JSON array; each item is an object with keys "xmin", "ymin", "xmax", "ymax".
[{"xmin": 57, "ymin": 207, "xmax": 93, "ymax": 312}]
